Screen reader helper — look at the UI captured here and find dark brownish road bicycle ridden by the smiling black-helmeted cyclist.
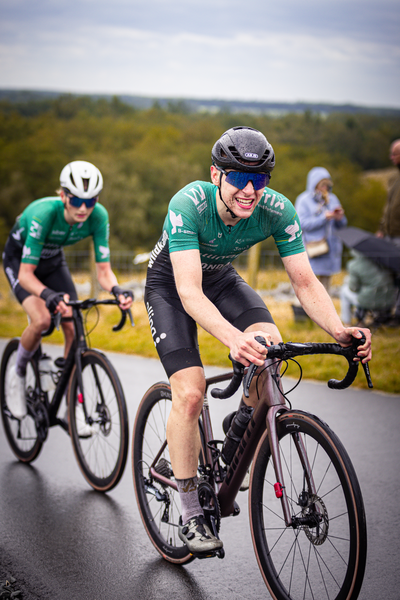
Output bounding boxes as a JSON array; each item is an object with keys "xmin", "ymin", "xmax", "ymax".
[{"xmin": 132, "ymin": 337, "xmax": 372, "ymax": 600}]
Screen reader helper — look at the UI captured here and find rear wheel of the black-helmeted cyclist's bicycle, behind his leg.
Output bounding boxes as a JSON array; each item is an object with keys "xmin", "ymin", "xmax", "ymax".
[{"xmin": 132, "ymin": 382, "xmax": 194, "ymax": 564}]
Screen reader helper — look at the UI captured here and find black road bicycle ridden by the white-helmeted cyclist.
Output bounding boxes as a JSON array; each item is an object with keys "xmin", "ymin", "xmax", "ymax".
[{"xmin": 0, "ymin": 298, "xmax": 133, "ymax": 492}]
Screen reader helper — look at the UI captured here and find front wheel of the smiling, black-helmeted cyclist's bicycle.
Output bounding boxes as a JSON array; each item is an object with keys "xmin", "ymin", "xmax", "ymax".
[{"xmin": 249, "ymin": 411, "xmax": 367, "ymax": 600}]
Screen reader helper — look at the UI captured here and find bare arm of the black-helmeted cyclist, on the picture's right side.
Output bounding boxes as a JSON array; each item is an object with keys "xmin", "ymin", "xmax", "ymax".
[{"xmin": 282, "ymin": 252, "xmax": 371, "ymax": 362}]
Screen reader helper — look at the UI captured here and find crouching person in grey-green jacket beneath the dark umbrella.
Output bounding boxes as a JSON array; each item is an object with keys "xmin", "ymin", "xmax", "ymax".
[{"xmin": 340, "ymin": 250, "xmax": 396, "ymax": 327}]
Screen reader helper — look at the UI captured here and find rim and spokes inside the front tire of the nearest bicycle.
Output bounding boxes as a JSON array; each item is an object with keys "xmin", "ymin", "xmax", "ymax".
[{"xmin": 252, "ymin": 414, "xmax": 358, "ymax": 600}]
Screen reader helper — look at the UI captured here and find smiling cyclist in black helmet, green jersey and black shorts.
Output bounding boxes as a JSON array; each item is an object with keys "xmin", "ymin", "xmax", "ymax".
[{"xmin": 145, "ymin": 127, "xmax": 371, "ymax": 554}]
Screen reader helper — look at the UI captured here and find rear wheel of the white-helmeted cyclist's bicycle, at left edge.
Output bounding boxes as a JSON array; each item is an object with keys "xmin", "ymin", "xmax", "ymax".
[{"xmin": 0, "ymin": 338, "xmax": 43, "ymax": 463}]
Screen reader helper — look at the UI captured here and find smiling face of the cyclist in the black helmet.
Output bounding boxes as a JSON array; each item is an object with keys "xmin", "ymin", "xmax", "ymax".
[{"xmin": 211, "ymin": 166, "xmax": 264, "ymax": 225}]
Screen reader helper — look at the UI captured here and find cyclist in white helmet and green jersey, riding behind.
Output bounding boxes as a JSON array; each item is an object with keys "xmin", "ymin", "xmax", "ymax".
[{"xmin": 3, "ymin": 161, "xmax": 133, "ymax": 419}]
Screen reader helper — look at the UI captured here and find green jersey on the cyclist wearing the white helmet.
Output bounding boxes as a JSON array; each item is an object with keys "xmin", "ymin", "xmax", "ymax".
[{"xmin": 10, "ymin": 197, "xmax": 110, "ymax": 265}]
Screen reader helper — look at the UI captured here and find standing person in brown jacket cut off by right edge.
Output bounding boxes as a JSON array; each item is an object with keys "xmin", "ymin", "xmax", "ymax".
[{"xmin": 376, "ymin": 139, "xmax": 400, "ymax": 325}]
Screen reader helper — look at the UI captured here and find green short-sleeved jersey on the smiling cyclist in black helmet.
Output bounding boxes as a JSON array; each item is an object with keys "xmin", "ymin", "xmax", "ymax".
[{"xmin": 149, "ymin": 181, "xmax": 304, "ymax": 272}]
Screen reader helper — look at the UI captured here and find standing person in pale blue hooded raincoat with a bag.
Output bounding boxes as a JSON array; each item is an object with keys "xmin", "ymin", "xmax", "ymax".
[{"xmin": 295, "ymin": 167, "xmax": 347, "ymax": 293}]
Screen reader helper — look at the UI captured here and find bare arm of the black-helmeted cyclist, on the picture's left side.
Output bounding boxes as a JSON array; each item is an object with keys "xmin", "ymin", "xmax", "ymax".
[{"xmin": 170, "ymin": 250, "xmax": 266, "ymax": 366}]
